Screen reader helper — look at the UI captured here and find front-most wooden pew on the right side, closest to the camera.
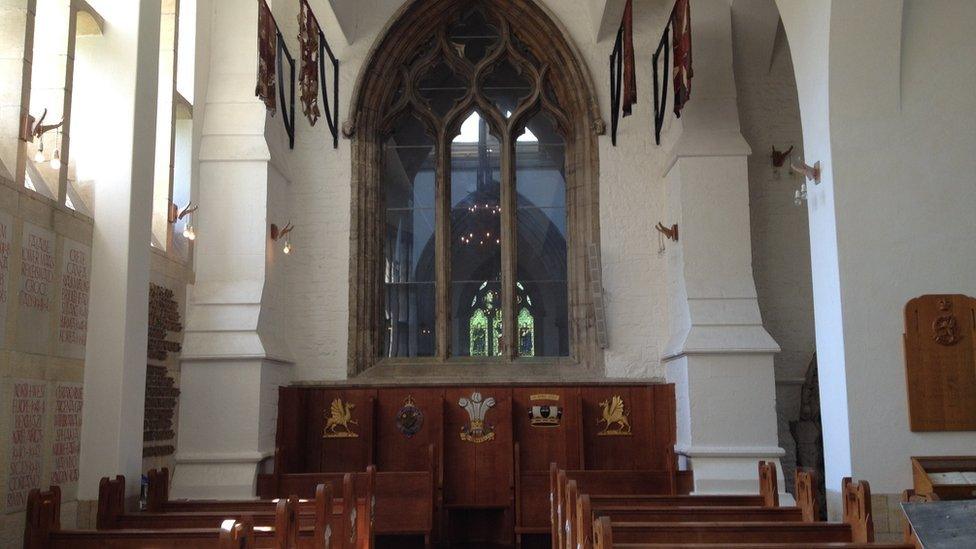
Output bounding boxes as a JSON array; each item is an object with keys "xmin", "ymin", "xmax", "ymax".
[{"xmin": 593, "ymin": 479, "xmax": 910, "ymax": 549}]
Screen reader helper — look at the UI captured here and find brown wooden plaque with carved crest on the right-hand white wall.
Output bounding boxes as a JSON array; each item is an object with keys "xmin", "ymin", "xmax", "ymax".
[{"xmin": 905, "ymin": 295, "xmax": 976, "ymax": 431}]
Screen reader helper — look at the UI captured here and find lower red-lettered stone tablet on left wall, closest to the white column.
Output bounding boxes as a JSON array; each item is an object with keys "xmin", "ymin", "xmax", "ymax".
[{"xmin": 50, "ymin": 383, "xmax": 82, "ymax": 488}]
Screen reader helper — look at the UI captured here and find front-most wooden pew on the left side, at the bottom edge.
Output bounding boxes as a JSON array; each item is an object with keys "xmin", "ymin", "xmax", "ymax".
[{"xmin": 24, "ymin": 486, "xmax": 298, "ymax": 549}]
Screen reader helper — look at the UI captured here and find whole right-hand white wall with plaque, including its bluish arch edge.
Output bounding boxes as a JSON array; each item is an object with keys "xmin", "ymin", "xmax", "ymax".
[{"xmin": 777, "ymin": 0, "xmax": 976, "ymax": 494}]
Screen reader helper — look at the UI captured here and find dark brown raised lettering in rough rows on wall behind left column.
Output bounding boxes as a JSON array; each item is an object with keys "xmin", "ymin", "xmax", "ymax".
[{"xmin": 142, "ymin": 284, "xmax": 183, "ymax": 457}]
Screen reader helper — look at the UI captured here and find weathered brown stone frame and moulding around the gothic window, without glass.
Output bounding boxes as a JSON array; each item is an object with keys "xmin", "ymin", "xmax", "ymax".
[{"xmin": 343, "ymin": 0, "xmax": 605, "ymax": 377}]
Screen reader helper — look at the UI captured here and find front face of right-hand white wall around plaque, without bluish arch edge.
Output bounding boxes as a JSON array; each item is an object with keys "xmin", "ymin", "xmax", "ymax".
[{"xmin": 830, "ymin": 0, "xmax": 976, "ymax": 493}]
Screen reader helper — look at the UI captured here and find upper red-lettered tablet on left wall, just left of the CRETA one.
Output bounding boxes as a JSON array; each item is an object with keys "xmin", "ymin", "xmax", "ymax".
[{"xmin": 17, "ymin": 223, "xmax": 55, "ymax": 353}]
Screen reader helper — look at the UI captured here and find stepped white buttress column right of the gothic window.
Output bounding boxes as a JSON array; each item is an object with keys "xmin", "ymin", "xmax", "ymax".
[{"xmin": 664, "ymin": 0, "xmax": 790, "ymax": 501}]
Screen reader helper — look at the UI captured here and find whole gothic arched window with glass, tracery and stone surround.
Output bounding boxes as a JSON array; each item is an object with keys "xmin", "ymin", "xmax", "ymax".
[{"xmin": 350, "ymin": 0, "xmax": 602, "ymax": 373}]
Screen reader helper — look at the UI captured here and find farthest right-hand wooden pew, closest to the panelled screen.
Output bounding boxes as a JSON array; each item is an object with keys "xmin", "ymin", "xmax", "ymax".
[{"xmin": 549, "ymin": 462, "xmax": 779, "ymax": 549}]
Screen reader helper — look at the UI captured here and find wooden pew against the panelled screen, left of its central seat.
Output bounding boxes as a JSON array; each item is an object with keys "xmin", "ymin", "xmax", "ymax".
[{"xmin": 258, "ymin": 444, "xmax": 438, "ymax": 545}]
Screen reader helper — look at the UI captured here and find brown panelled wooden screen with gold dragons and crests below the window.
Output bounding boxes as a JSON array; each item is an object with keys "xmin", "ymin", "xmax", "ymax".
[{"xmin": 276, "ymin": 383, "xmax": 675, "ymax": 543}]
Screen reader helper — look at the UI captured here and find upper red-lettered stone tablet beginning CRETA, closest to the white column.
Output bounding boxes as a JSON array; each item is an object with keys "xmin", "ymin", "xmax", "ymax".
[{"xmin": 57, "ymin": 238, "xmax": 91, "ymax": 360}]
